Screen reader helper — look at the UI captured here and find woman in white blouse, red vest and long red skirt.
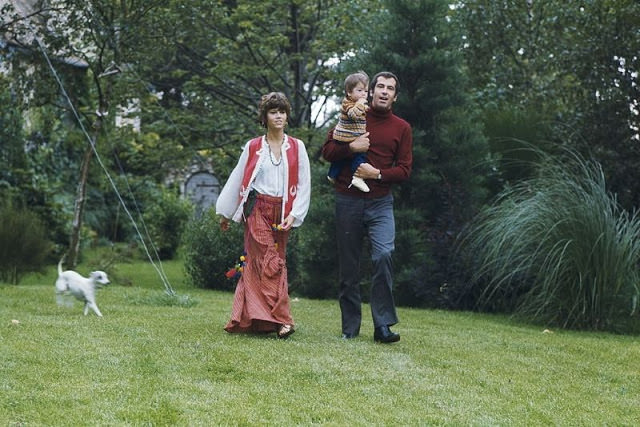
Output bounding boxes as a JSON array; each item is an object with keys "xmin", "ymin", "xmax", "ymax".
[{"xmin": 216, "ymin": 92, "xmax": 311, "ymax": 338}]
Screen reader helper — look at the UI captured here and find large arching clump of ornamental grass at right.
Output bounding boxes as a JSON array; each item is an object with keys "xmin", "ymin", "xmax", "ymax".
[{"xmin": 461, "ymin": 153, "xmax": 640, "ymax": 333}]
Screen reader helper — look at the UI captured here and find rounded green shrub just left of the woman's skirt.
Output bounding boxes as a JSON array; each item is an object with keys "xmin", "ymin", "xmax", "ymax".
[{"xmin": 183, "ymin": 209, "xmax": 244, "ymax": 290}]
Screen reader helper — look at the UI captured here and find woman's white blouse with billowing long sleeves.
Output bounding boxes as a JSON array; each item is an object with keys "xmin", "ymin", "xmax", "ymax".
[{"xmin": 216, "ymin": 135, "xmax": 311, "ymax": 227}]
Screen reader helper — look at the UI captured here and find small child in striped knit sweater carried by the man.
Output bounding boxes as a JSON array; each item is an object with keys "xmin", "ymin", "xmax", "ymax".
[{"xmin": 327, "ymin": 71, "xmax": 369, "ymax": 193}]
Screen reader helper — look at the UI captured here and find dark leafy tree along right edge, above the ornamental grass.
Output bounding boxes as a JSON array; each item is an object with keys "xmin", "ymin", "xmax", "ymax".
[{"xmin": 567, "ymin": 0, "xmax": 640, "ymax": 210}]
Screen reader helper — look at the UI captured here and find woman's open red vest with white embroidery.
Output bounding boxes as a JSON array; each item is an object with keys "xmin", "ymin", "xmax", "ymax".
[{"xmin": 238, "ymin": 136, "xmax": 298, "ymax": 221}]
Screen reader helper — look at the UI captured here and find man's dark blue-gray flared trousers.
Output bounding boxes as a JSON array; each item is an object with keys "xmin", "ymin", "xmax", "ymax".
[{"xmin": 335, "ymin": 193, "xmax": 398, "ymax": 335}]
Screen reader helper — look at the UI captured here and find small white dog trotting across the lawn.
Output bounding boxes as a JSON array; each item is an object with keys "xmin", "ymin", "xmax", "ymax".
[{"xmin": 56, "ymin": 260, "xmax": 110, "ymax": 317}]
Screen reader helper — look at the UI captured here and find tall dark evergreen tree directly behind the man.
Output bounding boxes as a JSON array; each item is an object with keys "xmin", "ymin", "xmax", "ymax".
[{"xmin": 362, "ymin": 0, "xmax": 488, "ymax": 306}]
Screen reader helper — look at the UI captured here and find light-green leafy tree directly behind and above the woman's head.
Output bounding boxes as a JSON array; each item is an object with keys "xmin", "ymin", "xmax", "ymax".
[{"xmin": 136, "ymin": 0, "xmax": 375, "ymax": 154}]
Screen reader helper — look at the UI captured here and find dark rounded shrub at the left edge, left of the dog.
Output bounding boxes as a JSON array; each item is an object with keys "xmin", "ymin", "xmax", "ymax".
[{"xmin": 0, "ymin": 206, "xmax": 51, "ymax": 284}]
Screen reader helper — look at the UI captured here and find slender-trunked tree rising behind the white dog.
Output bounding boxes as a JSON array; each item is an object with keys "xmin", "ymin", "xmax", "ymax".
[{"xmin": 5, "ymin": 0, "xmax": 178, "ymax": 266}]
